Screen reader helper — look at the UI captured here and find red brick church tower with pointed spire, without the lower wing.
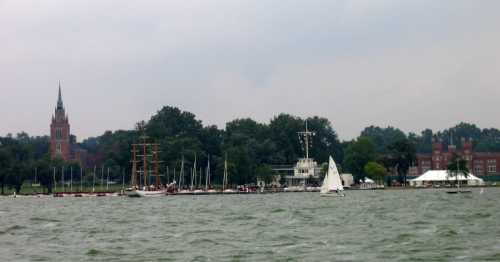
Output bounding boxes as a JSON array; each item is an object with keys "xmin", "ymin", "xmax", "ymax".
[{"xmin": 50, "ymin": 83, "xmax": 71, "ymax": 161}]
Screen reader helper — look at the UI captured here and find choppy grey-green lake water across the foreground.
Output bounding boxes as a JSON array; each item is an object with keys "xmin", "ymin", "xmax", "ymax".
[{"xmin": 0, "ymin": 188, "xmax": 500, "ymax": 261}]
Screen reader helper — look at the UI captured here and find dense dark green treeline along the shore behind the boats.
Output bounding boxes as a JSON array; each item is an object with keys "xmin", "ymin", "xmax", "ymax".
[{"xmin": 0, "ymin": 107, "xmax": 500, "ymax": 192}]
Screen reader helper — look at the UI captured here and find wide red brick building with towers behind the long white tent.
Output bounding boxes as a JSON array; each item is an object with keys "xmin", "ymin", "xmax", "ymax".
[{"xmin": 410, "ymin": 138, "xmax": 500, "ymax": 176}]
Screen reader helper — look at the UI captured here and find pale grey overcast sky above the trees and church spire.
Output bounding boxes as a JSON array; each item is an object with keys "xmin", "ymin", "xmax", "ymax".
[{"xmin": 0, "ymin": 0, "xmax": 500, "ymax": 140}]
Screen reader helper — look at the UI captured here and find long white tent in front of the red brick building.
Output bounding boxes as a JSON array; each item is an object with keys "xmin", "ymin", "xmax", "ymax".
[{"xmin": 410, "ymin": 170, "xmax": 484, "ymax": 186}]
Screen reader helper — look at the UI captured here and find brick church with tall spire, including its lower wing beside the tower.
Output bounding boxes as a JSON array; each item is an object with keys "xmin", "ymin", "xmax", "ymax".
[{"xmin": 50, "ymin": 84, "xmax": 87, "ymax": 165}]
